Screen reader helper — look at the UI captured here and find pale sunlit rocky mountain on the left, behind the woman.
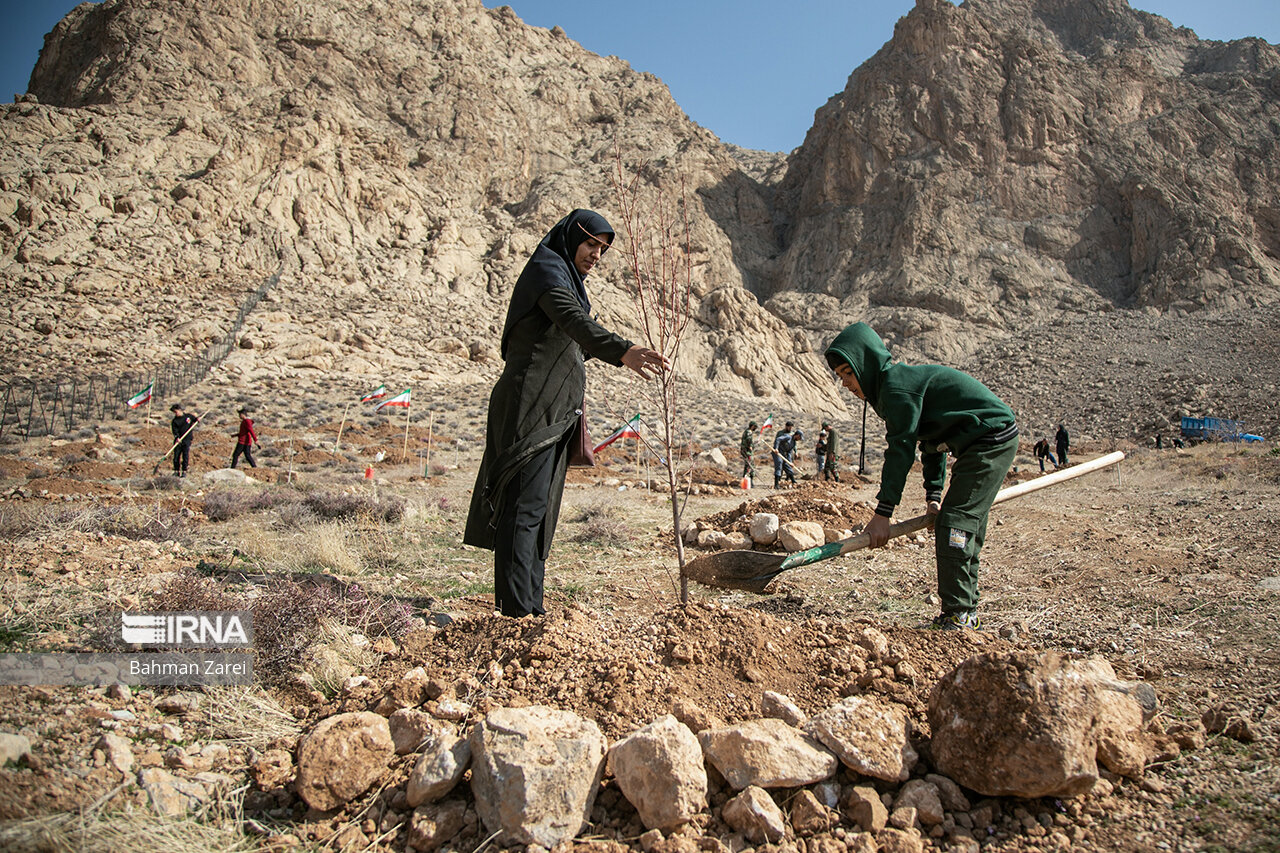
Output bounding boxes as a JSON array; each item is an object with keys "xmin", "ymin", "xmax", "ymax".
[{"xmin": 0, "ymin": 0, "xmax": 840, "ymax": 411}]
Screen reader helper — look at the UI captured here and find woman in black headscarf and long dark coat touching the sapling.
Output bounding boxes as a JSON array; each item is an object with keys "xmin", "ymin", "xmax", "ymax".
[{"xmin": 462, "ymin": 210, "xmax": 669, "ymax": 616}]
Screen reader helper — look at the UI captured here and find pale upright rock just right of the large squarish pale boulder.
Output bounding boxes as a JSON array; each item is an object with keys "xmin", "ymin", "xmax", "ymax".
[{"xmin": 607, "ymin": 715, "xmax": 707, "ymax": 831}]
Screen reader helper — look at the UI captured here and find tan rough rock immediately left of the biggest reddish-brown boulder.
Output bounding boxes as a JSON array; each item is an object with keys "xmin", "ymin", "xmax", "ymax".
[{"xmin": 805, "ymin": 695, "xmax": 918, "ymax": 781}]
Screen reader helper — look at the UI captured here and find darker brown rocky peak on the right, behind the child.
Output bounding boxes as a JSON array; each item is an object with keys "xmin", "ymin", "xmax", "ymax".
[{"xmin": 769, "ymin": 0, "xmax": 1280, "ymax": 360}]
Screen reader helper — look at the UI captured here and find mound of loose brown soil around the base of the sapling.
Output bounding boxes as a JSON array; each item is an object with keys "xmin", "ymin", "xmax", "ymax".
[{"xmin": 360, "ymin": 602, "xmax": 1009, "ymax": 739}]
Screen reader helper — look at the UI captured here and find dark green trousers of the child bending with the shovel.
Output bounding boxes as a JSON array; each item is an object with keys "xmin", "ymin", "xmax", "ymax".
[{"xmin": 933, "ymin": 438, "xmax": 1018, "ymax": 613}]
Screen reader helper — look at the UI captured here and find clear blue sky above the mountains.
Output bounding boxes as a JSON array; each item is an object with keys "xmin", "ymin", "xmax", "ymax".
[{"xmin": 0, "ymin": 0, "xmax": 1280, "ymax": 151}]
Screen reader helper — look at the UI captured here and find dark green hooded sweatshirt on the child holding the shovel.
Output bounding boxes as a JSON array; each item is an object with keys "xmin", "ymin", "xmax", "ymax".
[{"xmin": 826, "ymin": 323, "xmax": 1016, "ymax": 515}]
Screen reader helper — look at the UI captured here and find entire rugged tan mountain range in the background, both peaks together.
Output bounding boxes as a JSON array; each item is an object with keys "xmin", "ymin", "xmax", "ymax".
[{"xmin": 0, "ymin": 0, "xmax": 1280, "ymax": 432}]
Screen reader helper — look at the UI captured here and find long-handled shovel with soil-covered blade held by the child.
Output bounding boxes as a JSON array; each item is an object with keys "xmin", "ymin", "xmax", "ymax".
[{"xmin": 684, "ymin": 451, "xmax": 1124, "ymax": 593}]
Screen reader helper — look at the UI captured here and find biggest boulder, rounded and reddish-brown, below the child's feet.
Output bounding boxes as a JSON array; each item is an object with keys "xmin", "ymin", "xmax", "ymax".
[{"xmin": 928, "ymin": 652, "xmax": 1157, "ymax": 798}]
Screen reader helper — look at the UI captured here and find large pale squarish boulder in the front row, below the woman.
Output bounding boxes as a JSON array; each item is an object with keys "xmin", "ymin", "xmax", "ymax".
[{"xmin": 471, "ymin": 706, "xmax": 605, "ymax": 849}]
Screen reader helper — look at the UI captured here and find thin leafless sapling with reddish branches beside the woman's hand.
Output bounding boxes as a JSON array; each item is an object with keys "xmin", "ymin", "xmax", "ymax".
[{"xmin": 613, "ymin": 152, "xmax": 692, "ymax": 605}]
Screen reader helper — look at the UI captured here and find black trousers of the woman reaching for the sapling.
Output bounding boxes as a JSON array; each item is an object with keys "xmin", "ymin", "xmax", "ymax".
[{"xmin": 493, "ymin": 447, "xmax": 557, "ymax": 616}]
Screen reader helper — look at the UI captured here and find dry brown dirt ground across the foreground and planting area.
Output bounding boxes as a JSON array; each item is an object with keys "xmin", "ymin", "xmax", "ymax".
[{"xmin": 0, "ymin": 428, "xmax": 1280, "ymax": 853}]
